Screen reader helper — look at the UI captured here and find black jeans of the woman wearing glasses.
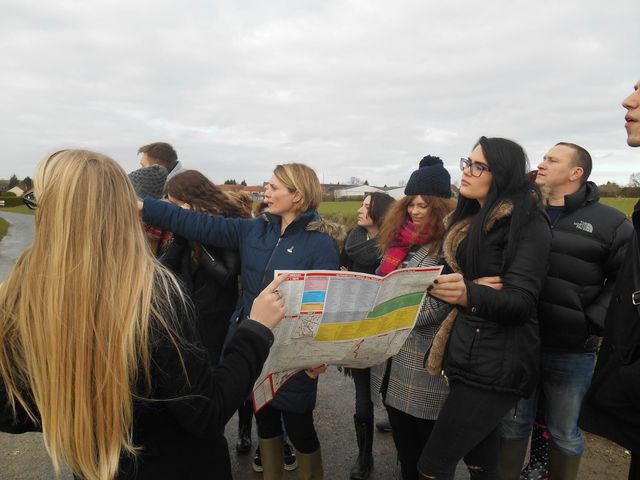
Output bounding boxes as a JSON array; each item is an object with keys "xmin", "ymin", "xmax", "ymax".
[{"xmin": 418, "ymin": 380, "xmax": 518, "ymax": 480}]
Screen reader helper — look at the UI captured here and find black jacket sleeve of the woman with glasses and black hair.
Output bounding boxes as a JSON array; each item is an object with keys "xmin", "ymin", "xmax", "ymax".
[{"xmin": 465, "ymin": 211, "xmax": 551, "ymax": 324}]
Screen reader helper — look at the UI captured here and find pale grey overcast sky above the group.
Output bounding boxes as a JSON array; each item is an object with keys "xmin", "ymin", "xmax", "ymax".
[{"xmin": 0, "ymin": 0, "xmax": 640, "ymax": 186}]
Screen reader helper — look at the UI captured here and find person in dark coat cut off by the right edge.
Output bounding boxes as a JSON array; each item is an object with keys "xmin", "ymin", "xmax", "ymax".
[{"xmin": 580, "ymin": 81, "xmax": 640, "ymax": 480}]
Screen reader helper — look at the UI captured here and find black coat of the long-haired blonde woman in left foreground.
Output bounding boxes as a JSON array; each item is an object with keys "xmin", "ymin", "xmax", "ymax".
[{"xmin": 0, "ymin": 286, "xmax": 273, "ymax": 480}]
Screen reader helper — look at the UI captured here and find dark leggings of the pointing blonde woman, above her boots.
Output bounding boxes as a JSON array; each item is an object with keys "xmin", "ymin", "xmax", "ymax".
[{"xmin": 256, "ymin": 405, "xmax": 320, "ymax": 453}]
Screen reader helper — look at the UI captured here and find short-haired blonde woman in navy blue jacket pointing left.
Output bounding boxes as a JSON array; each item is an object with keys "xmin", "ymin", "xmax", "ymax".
[{"xmin": 142, "ymin": 163, "xmax": 340, "ymax": 480}]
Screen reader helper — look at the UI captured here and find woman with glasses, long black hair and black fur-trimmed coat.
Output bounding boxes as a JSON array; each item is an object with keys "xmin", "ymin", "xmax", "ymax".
[{"xmin": 418, "ymin": 137, "xmax": 551, "ymax": 480}]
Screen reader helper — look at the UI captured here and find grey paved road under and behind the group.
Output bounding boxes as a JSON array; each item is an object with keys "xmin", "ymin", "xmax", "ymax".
[{"xmin": 0, "ymin": 212, "xmax": 469, "ymax": 480}]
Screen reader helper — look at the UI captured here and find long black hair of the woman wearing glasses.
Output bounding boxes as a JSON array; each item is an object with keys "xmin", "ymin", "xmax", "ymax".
[{"xmin": 450, "ymin": 137, "xmax": 542, "ymax": 279}]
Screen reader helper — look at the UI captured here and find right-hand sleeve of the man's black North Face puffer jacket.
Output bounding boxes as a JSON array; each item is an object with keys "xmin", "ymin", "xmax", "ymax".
[{"xmin": 585, "ymin": 218, "xmax": 633, "ymax": 336}]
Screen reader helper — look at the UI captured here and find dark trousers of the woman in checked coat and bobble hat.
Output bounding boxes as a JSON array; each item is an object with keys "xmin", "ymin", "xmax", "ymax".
[{"xmin": 386, "ymin": 405, "xmax": 436, "ymax": 480}]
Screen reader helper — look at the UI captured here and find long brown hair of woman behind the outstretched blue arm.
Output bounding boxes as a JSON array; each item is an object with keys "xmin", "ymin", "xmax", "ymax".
[{"xmin": 167, "ymin": 170, "xmax": 251, "ymax": 218}]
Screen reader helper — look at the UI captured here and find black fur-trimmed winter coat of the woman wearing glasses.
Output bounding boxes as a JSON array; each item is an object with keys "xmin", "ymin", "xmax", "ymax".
[{"xmin": 443, "ymin": 202, "xmax": 551, "ymax": 397}]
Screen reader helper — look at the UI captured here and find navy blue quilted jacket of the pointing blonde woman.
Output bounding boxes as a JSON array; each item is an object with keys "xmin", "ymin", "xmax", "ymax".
[{"xmin": 142, "ymin": 198, "xmax": 339, "ymax": 413}]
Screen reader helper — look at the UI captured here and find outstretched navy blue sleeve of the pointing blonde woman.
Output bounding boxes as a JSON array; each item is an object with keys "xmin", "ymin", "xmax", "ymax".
[{"xmin": 142, "ymin": 197, "xmax": 252, "ymax": 249}]
